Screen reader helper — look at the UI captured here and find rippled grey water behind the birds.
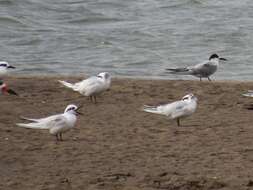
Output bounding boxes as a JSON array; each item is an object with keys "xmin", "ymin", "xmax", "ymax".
[{"xmin": 0, "ymin": 0, "xmax": 253, "ymax": 80}]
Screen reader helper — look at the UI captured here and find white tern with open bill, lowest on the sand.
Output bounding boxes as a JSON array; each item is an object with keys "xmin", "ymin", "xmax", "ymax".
[{"xmin": 16, "ymin": 104, "xmax": 81, "ymax": 141}]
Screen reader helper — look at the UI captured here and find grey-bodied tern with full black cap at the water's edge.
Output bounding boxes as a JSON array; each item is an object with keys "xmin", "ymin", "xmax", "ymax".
[{"xmin": 166, "ymin": 54, "xmax": 227, "ymax": 81}]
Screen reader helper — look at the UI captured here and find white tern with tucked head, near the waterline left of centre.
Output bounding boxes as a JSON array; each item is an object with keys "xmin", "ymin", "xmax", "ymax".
[{"xmin": 59, "ymin": 72, "xmax": 111, "ymax": 103}]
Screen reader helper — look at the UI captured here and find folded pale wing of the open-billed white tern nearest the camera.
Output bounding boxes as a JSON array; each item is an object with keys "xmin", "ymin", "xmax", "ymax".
[{"xmin": 16, "ymin": 114, "xmax": 66, "ymax": 129}]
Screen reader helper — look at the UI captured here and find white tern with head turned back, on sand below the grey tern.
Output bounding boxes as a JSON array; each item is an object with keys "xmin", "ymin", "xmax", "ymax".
[{"xmin": 143, "ymin": 94, "xmax": 198, "ymax": 126}]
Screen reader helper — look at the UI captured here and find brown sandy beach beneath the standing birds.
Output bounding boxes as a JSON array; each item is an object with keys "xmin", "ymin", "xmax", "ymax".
[{"xmin": 0, "ymin": 77, "xmax": 253, "ymax": 190}]
